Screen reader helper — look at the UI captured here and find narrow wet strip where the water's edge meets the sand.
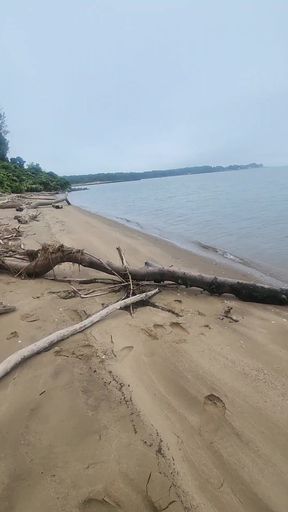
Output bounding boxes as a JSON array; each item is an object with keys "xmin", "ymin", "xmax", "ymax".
[{"xmin": 71, "ymin": 202, "xmax": 287, "ymax": 287}]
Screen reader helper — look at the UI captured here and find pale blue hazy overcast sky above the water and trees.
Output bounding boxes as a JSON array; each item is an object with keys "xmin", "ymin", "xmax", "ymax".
[{"xmin": 0, "ymin": 0, "xmax": 288, "ymax": 174}]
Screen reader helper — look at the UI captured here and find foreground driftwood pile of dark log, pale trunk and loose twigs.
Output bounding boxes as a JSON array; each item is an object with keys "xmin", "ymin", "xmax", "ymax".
[{"xmin": 0, "ymin": 241, "xmax": 288, "ymax": 379}]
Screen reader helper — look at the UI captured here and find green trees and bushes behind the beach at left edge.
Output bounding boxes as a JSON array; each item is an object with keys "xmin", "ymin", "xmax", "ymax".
[{"xmin": 0, "ymin": 111, "xmax": 70, "ymax": 194}]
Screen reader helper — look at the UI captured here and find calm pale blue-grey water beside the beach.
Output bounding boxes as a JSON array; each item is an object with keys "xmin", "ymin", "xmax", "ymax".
[{"xmin": 70, "ymin": 166, "xmax": 288, "ymax": 282}]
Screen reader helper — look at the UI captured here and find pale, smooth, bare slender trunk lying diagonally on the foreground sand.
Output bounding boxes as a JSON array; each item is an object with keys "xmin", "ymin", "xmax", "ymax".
[{"xmin": 0, "ymin": 289, "xmax": 158, "ymax": 379}]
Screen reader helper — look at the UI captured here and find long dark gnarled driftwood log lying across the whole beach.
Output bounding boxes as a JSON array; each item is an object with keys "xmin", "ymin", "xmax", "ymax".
[{"xmin": 0, "ymin": 245, "xmax": 288, "ymax": 305}]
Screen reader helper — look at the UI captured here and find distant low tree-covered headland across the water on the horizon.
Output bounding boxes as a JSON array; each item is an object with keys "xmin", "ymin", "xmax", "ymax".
[{"xmin": 65, "ymin": 163, "xmax": 263, "ymax": 185}]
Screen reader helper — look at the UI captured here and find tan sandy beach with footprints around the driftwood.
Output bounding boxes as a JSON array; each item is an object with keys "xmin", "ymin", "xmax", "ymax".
[{"xmin": 0, "ymin": 207, "xmax": 288, "ymax": 512}]
